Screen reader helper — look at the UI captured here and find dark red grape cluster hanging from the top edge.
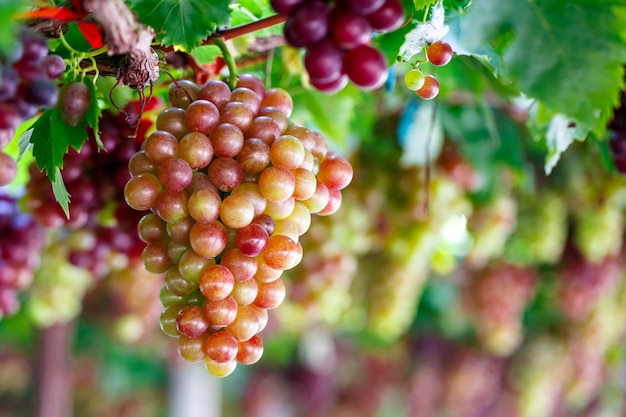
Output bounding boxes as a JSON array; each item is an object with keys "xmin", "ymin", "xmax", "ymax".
[{"xmin": 271, "ymin": 0, "xmax": 405, "ymax": 93}]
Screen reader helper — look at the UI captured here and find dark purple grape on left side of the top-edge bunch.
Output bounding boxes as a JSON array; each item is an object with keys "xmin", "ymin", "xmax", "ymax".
[{"xmin": 285, "ymin": 1, "xmax": 330, "ymax": 47}]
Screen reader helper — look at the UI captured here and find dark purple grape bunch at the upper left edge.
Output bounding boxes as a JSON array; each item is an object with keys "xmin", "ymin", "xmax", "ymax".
[{"xmin": 0, "ymin": 29, "xmax": 65, "ymax": 185}]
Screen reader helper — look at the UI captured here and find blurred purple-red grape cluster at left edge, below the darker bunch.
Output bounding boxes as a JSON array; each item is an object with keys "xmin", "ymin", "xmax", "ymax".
[{"xmin": 0, "ymin": 194, "xmax": 45, "ymax": 318}]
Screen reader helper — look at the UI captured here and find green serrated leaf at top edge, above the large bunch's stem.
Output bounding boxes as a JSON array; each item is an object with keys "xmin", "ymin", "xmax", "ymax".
[{"xmin": 130, "ymin": 0, "xmax": 230, "ymax": 51}]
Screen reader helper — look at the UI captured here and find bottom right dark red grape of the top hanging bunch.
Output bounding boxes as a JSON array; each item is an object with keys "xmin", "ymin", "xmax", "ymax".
[{"xmin": 344, "ymin": 45, "xmax": 388, "ymax": 90}]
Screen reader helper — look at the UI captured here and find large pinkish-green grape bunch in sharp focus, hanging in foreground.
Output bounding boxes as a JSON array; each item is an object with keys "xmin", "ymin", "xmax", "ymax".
[{"xmin": 124, "ymin": 74, "xmax": 353, "ymax": 376}]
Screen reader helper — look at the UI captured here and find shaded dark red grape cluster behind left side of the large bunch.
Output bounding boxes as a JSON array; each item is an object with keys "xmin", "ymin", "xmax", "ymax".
[{"xmin": 25, "ymin": 107, "xmax": 145, "ymax": 277}]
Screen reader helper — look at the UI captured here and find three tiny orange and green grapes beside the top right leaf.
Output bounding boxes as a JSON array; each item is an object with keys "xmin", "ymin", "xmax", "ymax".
[{"xmin": 404, "ymin": 41, "xmax": 454, "ymax": 100}]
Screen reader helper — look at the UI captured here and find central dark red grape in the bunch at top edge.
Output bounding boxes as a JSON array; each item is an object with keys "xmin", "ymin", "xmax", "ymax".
[{"xmin": 331, "ymin": 8, "xmax": 372, "ymax": 49}]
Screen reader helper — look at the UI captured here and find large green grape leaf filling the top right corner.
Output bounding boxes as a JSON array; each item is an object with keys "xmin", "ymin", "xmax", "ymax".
[{"xmin": 461, "ymin": 0, "xmax": 626, "ymax": 132}]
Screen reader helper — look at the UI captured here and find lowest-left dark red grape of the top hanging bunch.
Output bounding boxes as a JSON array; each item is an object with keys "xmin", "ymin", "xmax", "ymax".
[{"xmin": 304, "ymin": 39, "xmax": 343, "ymax": 83}]
